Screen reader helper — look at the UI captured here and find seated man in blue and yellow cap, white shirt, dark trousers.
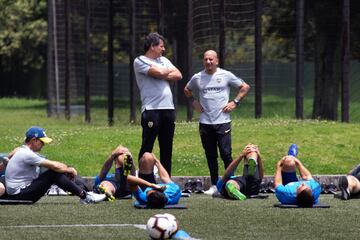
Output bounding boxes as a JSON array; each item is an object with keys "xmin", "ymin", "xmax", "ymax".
[{"xmin": 5, "ymin": 126, "xmax": 102, "ymax": 204}]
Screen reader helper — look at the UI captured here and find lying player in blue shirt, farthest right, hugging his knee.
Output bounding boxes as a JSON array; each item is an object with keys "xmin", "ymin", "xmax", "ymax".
[{"xmin": 274, "ymin": 155, "xmax": 321, "ymax": 207}]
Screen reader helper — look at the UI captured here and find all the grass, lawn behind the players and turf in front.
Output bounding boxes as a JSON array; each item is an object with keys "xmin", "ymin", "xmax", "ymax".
[{"xmin": 0, "ymin": 98, "xmax": 360, "ymax": 240}]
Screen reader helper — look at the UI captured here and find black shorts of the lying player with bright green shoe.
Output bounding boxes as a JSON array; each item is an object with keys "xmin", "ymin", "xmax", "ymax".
[{"xmin": 221, "ymin": 176, "xmax": 261, "ymax": 198}]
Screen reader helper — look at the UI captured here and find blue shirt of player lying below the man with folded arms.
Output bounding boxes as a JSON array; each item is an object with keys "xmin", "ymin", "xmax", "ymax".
[{"xmin": 134, "ymin": 182, "xmax": 181, "ymax": 205}]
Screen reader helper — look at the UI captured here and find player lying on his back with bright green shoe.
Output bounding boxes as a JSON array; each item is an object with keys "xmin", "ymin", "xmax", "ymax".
[{"xmin": 217, "ymin": 143, "xmax": 264, "ymax": 200}]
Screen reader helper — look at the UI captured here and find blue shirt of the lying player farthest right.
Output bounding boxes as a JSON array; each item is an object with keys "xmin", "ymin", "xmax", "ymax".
[{"xmin": 275, "ymin": 178, "xmax": 321, "ymax": 204}]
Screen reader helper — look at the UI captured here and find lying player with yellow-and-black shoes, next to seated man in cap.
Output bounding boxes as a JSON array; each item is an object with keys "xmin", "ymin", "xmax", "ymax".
[{"xmin": 94, "ymin": 145, "xmax": 135, "ymax": 201}]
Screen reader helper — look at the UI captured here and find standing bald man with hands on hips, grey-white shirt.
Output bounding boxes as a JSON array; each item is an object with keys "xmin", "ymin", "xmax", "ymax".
[{"xmin": 184, "ymin": 50, "xmax": 250, "ymax": 195}]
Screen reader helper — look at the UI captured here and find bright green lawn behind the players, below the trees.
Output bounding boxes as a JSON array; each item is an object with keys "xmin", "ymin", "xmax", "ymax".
[{"xmin": 0, "ymin": 98, "xmax": 360, "ymax": 176}]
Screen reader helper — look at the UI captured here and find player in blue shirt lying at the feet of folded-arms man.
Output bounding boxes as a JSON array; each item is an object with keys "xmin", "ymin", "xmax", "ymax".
[{"xmin": 127, "ymin": 152, "xmax": 181, "ymax": 208}]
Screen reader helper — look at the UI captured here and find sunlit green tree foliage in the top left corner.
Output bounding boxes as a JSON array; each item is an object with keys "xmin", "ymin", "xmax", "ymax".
[{"xmin": 0, "ymin": 0, "xmax": 47, "ymax": 71}]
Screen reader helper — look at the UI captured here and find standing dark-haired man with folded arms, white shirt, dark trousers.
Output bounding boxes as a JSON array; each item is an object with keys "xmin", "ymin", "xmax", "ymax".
[{"xmin": 134, "ymin": 32, "xmax": 182, "ymax": 175}]
